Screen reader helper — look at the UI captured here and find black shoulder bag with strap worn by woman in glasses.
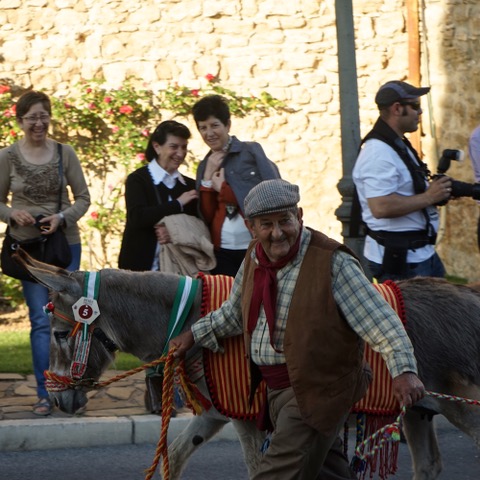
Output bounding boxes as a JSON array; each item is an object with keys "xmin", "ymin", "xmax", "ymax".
[{"xmin": 1, "ymin": 144, "xmax": 72, "ymax": 282}]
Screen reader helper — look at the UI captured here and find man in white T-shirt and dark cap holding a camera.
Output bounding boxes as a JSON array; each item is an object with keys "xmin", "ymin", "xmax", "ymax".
[{"xmin": 353, "ymin": 81, "xmax": 452, "ymax": 282}]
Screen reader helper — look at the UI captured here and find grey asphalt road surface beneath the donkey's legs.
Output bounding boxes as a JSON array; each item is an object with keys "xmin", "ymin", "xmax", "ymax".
[{"xmin": 0, "ymin": 418, "xmax": 480, "ymax": 480}]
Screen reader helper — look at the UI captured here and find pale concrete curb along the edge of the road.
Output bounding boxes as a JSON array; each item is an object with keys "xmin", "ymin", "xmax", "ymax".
[{"xmin": 0, "ymin": 415, "xmax": 238, "ymax": 452}]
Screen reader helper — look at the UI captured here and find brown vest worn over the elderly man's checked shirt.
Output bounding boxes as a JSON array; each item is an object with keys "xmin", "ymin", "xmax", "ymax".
[{"xmin": 242, "ymin": 230, "xmax": 371, "ymax": 434}]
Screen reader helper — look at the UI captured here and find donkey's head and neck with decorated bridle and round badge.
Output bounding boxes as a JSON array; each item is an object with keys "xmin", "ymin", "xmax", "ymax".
[{"xmin": 16, "ymin": 249, "xmax": 197, "ymax": 413}]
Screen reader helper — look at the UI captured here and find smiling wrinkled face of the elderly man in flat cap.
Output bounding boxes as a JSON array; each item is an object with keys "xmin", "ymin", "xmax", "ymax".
[{"xmin": 247, "ymin": 208, "xmax": 302, "ymax": 262}]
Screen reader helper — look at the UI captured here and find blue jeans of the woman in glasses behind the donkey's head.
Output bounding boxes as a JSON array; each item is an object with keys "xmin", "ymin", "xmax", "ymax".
[{"xmin": 22, "ymin": 243, "xmax": 82, "ymax": 398}]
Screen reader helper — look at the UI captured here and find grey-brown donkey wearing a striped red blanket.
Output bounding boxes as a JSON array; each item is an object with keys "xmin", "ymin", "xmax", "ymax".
[{"xmin": 14, "ymin": 252, "xmax": 480, "ymax": 480}]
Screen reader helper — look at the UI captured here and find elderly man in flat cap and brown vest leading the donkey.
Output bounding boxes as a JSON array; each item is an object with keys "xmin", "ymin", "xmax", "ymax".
[{"xmin": 170, "ymin": 179, "xmax": 424, "ymax": 480}]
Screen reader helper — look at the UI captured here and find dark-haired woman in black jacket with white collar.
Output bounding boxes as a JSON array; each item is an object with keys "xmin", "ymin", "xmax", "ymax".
[{"xmin": 118, "ymin": 120, "xmax": 198, "ymax": 271}]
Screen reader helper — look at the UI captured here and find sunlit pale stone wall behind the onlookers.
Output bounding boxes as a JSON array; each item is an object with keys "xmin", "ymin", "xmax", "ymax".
[{"xmin": 0, "ymin": 0, "xmax": 480, "ymax": 279}]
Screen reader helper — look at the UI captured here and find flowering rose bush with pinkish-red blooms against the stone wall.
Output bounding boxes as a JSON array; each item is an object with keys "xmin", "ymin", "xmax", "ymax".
[{"xmin": 0, "ymin": 74, "xmax": 285, "ymax": 268}]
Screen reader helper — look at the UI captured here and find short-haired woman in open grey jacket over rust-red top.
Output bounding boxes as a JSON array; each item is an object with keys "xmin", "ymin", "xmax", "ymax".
[{"xmin": 192, "ymin": 95, "xmax": 280, "ymax": 276}]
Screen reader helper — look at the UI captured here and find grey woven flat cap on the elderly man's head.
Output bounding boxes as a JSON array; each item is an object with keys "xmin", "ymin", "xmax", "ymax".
[{"xmin": 243, "ymin": 178, "xmax": 300, "ymax": 218}]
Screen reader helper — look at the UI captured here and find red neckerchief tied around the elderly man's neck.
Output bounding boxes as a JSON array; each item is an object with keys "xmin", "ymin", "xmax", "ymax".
[{"xmin": 248, "ymin": 230, "xmax": 302, "ymax": 353}]
